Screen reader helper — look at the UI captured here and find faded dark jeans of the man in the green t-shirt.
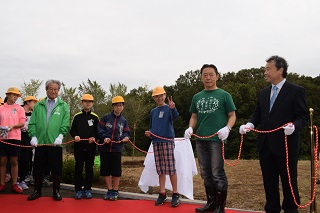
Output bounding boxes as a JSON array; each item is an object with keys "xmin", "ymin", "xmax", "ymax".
[{"xmin": 196, "ymin": 140, "xmax": 228, "ymax": 191}]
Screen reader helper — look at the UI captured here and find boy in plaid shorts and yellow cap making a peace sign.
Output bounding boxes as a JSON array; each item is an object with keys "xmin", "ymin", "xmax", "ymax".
[{"xmin": 145, "ymin": 87, "xmax": 180, "ymax": 207}]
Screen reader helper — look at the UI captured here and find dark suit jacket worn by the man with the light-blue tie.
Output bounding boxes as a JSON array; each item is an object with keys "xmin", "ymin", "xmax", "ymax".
[{"xmin": 250, "ymin": 80, "xmax": 308, "ymax": 156}]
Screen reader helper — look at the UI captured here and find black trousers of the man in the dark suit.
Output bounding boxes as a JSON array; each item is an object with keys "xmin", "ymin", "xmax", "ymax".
[{"xmin": 259, "ymin": 145, "xmax": 300, "ymax": 213}]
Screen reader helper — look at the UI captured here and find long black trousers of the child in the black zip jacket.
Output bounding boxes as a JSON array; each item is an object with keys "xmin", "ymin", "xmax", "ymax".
[{"xmin": 74, "ymin": 150, "xmax": 95, "ymax": 191}]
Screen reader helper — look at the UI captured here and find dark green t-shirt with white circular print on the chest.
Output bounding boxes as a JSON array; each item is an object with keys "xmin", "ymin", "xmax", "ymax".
[{"xmin": 190, "ymin": 88, "xmax": 236, "ymax": 142}]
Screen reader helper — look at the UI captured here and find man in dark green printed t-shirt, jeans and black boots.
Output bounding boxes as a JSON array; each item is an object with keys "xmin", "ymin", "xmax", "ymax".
[{"xmin": 185, "ymin": 64, "xmax": 236, "ymax": 213}]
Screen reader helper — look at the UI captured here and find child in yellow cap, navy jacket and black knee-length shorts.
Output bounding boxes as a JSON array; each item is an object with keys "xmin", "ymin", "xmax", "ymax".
[{"xmin": 98, "ymin": 96, "xmax": 130, "ymax": 200}]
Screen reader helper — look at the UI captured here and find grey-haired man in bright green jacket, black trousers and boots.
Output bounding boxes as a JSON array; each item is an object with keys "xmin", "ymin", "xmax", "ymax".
[{"xmin": 28, "ymin": 80, "xmax": 70, "ymax": 201}]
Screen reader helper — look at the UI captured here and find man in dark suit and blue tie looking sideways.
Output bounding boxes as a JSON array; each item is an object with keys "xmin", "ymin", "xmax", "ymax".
[{"xmin": 239, "ymin": 56, "xmax": 308, "ymax": 213}]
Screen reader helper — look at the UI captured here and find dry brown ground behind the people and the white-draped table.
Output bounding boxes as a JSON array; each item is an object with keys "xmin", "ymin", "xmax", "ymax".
[{"xmin": 95, "ymin": 157, "xmax": 320, "ymax": 212}]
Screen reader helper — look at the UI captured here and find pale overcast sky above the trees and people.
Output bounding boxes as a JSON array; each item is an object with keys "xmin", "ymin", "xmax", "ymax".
[{"xmin": 0, "ymin": 0, "xmax": 320, "ymax": 98}]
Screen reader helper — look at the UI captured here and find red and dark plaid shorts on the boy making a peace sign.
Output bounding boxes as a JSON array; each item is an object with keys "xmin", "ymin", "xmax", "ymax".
[{"xmin": 152, "ymin": 141, "xmax": 176, "ymax": 175}]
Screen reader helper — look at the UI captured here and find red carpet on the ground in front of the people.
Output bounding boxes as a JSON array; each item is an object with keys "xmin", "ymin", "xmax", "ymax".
[{"xmin": 0, "ymin": 194, "xmax": 264, "ymax": 213}]
